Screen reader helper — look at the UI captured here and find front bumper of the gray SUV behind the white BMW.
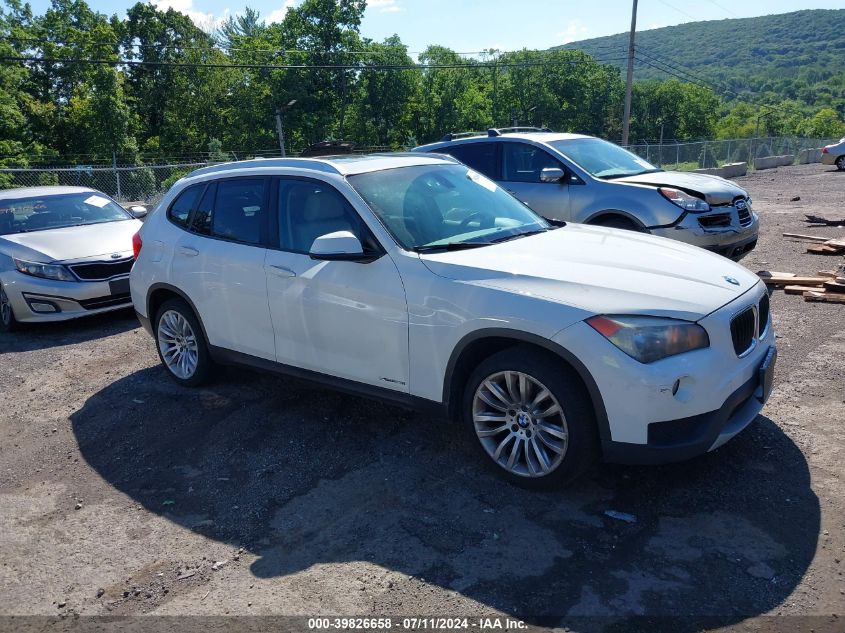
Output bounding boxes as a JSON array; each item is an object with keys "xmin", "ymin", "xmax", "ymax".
[{"xmin": 649, "ymin": 206, "xmax": 760, "ymax": 261}]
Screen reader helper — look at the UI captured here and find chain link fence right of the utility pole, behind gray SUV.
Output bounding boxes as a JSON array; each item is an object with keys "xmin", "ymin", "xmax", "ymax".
[{"xmin": 626, "ymin": 136, "xmax": 836, "ymax": 170}]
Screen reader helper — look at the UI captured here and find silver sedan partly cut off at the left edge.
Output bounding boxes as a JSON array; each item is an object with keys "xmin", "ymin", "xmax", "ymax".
[{"xmin": 0, "ymin": 187, "xmax": 141, "ymax": 331}]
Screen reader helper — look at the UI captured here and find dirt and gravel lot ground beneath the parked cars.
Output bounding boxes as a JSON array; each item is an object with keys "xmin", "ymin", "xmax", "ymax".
[{"xmin": 0, "ymin": 165, "xmax": 845, "ymax": 631}]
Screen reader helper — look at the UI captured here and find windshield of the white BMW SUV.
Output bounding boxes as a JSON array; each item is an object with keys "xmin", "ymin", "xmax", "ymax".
[{"xmin": 349, "ymin": 164, "xmax": 551, "ymax": 252}]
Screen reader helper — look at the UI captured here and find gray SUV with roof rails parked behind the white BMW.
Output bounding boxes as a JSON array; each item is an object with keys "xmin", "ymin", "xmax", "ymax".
[{"xmin": 414, "ymin": 128, "xmax": 758, "ymax": 260}]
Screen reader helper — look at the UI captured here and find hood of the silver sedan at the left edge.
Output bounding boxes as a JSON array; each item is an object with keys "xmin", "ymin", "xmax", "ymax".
[{"xmin": 0, "ymin": 220, "xmax": 142, "ymax": 263}]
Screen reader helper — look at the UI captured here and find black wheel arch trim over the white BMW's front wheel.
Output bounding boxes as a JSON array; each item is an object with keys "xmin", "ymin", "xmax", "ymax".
[{"xmin": 443, "ymin": 328, "xmax": 610, "ymax": 443}]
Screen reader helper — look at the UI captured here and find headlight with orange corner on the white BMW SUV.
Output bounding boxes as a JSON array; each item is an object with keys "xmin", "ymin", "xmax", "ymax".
[{"xmin": 587, "ymin": 315, "xmax": 710, "ymax": 363}]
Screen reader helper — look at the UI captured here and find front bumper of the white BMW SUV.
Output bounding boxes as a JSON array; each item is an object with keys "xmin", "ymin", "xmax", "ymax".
[{"xmin": 553, "ymin": 282, "xmax": 775, "ymax": 463}]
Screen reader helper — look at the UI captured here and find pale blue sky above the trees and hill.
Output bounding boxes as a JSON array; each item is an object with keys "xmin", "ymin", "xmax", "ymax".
[{"xmin": 24, "ymin": 0, "xmax": 845, "ymax": 52}]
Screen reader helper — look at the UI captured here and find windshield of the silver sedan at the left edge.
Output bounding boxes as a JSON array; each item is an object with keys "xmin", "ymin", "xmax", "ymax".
[{"xmin": 0, "ymin": 191, "xmax": 132, "ymax": 235}]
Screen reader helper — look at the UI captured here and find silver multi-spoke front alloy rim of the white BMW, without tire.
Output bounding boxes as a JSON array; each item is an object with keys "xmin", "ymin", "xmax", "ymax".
[{"xmin": 472, "ymin": 371, "xmax": 569, "ymax": 477}]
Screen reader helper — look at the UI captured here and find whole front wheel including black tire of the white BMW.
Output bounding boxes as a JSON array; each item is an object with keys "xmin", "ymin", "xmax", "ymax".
[{"xmin": 463, "ymin": 346, "xmax": 598, "ymax": 488}]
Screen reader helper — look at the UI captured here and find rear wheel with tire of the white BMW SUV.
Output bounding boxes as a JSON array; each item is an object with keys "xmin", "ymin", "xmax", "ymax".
[{"xmin": 154, "ymin": 298, "xmax": 213, "ymax": 387}]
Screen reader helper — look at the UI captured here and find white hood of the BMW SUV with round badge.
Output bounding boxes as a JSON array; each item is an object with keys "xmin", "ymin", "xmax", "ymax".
[{"xmin": 420, "ymin": 224, "xmax": 760, "ymax": 321}]
